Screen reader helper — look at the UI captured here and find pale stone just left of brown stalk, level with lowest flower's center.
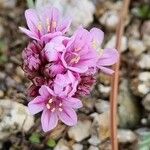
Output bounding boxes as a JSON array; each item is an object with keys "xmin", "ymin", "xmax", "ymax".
[{"xmin": 95, "ymin": 99, "xmax": 110, "ymax": 113}]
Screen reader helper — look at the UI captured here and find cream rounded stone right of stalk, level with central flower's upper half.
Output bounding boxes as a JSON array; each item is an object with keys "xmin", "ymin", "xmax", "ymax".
[{"xmin": 128, "ymin": 39, "xmax": 146, "ymax": 56}]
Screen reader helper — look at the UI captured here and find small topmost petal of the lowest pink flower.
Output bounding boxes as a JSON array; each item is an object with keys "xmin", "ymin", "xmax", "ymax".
[{"xmin": 39, "ymin": 85, "xmax": 54, "ymax": 97}]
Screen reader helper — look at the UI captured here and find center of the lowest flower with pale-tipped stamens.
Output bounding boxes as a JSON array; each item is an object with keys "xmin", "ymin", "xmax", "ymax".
[{"xmin": 46, "ymin": 99, "xmax": 63, "ymax": 112}]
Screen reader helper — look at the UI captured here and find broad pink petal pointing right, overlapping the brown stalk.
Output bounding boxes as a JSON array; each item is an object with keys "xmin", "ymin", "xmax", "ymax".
[{"xmin": 97, "ymin": 48, "xmax": 119, "ymax": 67}]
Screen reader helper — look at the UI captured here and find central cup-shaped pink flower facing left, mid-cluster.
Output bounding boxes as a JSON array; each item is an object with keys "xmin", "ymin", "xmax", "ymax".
[{"xmin": 61, "ymin": 27, "xmax": 98, "ymax": 73}]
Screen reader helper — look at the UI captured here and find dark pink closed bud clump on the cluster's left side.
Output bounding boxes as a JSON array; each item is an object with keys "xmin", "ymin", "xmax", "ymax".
[{"xmin": 22, "ymin": 41, "xmax": 42, "ymax": 76}]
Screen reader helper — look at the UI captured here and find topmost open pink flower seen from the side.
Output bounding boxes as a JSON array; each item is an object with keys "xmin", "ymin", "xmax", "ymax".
[{"xmin": 20, "ymin": 7, "xmax": 71, "ymax": 41}]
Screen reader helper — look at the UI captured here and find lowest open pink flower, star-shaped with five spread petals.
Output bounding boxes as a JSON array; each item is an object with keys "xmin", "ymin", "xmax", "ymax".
[{"xmin": 28, "ymin": 85, "xmax": 82, "ymax": 132}]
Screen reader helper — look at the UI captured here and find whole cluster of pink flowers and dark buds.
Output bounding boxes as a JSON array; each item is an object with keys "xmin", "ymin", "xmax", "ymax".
[{"xmin": 20, "ymin": 7, "xmax": 119, "ymax": 132}]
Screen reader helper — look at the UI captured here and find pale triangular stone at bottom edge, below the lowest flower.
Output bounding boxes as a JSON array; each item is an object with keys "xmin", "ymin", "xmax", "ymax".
[{"xmin": 54, "ymin": 139, "xmax": 70, "ymax": 150}]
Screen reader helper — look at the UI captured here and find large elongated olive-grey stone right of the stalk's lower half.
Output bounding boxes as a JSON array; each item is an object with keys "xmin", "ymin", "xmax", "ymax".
[{"xmin": 118, "ymin": 79, "xmax": 141, "ymax": 129}]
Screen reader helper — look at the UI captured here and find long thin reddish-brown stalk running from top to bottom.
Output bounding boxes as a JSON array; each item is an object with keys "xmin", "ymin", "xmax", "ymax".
[{"xmin": 110, "ymin": 0, "xmax": 130, "ymax": 150}]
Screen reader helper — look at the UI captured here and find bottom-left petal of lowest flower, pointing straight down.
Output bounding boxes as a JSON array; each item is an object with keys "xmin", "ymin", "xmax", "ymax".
[{"xmin": 41, "ymin": 109, "xmax": 58, "ymax": 132}]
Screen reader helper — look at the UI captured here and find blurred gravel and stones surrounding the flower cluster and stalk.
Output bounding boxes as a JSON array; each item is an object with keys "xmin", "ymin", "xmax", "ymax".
[{"xmin": 0, "ymin": 0, "xmax": 150, "ymax": 150}]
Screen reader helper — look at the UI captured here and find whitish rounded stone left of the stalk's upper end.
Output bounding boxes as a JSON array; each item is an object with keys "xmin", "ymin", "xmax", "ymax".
[{"xmin": 99, "ymin": 10, "xmax": 119, "ymax": 31}]
